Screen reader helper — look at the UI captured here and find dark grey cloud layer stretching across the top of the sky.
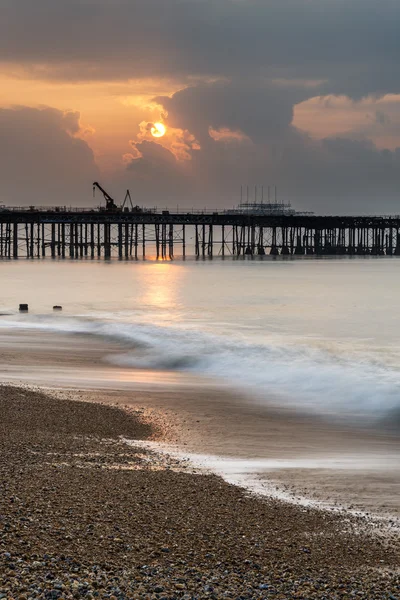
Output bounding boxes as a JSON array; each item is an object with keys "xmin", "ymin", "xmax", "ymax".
[{"xmin": 0, "ymin": 0, "xmax": 400, "ymax": 95}]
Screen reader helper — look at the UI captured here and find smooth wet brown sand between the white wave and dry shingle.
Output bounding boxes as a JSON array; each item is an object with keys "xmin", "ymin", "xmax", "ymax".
[{"xmin": 0, "ymin": 331, "xmax": 400, "ymax": 516}]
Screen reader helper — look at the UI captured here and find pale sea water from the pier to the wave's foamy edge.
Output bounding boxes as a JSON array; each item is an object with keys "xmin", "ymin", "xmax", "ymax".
[{"xmin": 0, "ymin": 258, "xmax": 400, "ymax": 420}]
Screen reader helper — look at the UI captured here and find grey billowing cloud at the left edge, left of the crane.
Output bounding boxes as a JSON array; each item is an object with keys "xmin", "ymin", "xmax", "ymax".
[{"xmin": 0, "ymin": 107, "xmax": 97, "ymax": 205}]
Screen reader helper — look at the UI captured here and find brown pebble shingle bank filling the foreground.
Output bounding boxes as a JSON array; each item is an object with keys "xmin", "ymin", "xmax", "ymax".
[{"xmin": 0, "ymin": 386, "xmax": 400, "ymax": 600}]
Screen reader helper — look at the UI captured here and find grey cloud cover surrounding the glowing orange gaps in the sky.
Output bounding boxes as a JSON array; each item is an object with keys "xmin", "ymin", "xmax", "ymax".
[{"xmin": 0, "ymin": 0, "xmax": 400, "ymax": 213}]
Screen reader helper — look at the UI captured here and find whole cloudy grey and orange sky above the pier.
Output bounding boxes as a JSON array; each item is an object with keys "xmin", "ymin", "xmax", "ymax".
[{"xmin": 0, "ymin": 0, "xmax": 400, "ymax": 214}]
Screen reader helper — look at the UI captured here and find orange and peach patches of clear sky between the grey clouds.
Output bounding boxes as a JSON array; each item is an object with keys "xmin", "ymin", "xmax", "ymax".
[{"xmin": 0, "ymin": 67, "xmax": 400, "ymax": 183}]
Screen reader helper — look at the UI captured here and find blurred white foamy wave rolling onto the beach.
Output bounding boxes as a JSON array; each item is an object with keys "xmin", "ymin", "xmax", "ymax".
[{"xmin": 0, "ymin": 315, "xmax": 400, "ymax": 420}]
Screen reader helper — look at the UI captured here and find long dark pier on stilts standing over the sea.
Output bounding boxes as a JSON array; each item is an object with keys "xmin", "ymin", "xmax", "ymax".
[{"xmin": 0, "ymin": 207, "xmax": 400, "ymax": 260}]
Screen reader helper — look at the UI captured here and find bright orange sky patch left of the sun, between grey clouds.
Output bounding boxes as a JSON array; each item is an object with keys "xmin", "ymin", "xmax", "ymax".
[{"xmin": 0, "ymin": 75, "xmax": 188, "ymax": 172}]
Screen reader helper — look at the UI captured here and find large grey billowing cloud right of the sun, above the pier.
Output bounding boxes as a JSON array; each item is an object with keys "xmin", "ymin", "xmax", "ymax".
[{"xmin": 119, "ymin": 83, "xmax": 400, "ymax": 214}]
